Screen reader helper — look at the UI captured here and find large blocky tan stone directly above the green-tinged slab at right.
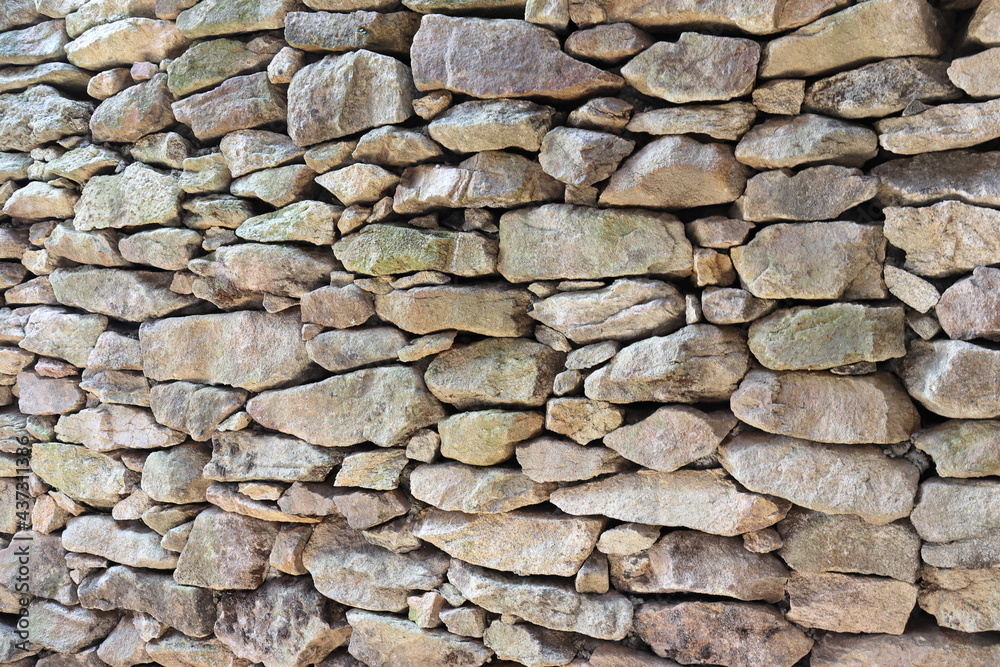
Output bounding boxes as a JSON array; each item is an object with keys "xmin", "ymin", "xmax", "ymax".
[{"xmin": 730, "ymin": 222, "xmax": 888, "ymax": 299}]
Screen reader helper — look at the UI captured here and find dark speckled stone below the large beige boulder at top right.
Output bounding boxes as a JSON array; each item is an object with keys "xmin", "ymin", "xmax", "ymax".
[{"xmin": 804, "ymin": 58, "xmax": 961, "ymax": 118}]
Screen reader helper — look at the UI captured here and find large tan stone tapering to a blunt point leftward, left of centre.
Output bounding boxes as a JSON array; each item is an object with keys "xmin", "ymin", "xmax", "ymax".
[{"xmin": 246, "ymin": 366, "xmax": 445, "ymax": 447}]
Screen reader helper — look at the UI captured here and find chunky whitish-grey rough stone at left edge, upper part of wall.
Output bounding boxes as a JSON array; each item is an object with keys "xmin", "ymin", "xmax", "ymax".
[{"xmin": 0, "ymin": 85, "xmax": 94, "ymax": 151}]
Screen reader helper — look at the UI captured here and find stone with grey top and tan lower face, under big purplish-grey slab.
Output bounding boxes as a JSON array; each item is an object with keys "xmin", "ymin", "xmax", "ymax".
[{"xmin": 427, "ymin": 99, "xmax": 555, "ymax": 153}]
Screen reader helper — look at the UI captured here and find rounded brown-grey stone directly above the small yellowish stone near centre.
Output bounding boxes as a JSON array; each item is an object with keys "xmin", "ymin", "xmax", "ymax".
[{"xmin": 424, "ymin": 338, "xmax": 564, "ymax": 416}]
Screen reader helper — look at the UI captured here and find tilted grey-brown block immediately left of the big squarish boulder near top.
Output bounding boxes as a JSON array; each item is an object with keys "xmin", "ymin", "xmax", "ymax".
[{"xmin": 171, "ymin": 72, "xmax": 286, "ymax": 141}]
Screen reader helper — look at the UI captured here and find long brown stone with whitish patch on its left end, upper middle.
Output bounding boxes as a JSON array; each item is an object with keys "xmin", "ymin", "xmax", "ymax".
[{"xmin": 392, "ymin": 151, "xmax": 564, "ymax": 213}]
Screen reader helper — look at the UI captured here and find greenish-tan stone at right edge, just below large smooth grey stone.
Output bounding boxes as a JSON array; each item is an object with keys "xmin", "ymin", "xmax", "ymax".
[{"xmin": 912, "ymin": 419, "xmax": 1000, "ymax": 477}]
